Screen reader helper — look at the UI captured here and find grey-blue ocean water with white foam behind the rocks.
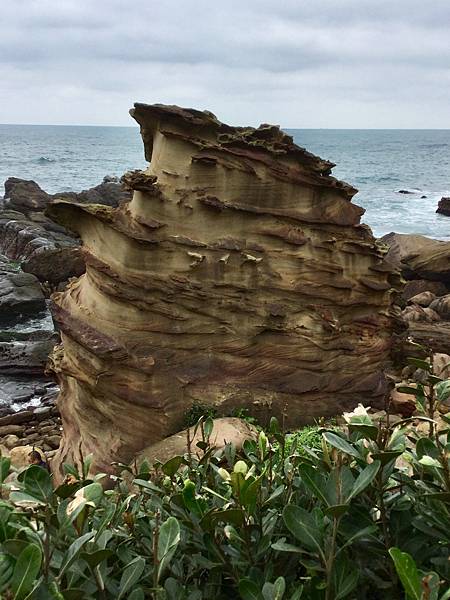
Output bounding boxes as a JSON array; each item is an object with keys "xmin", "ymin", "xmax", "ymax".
[{"xmin": 0, "ymin": 125, "xmax": 450, "ymax": 239}]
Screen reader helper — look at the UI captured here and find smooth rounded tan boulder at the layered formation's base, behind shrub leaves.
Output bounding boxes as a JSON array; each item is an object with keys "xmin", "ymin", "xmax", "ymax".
[{"xmin": 136, "ymin": 417, "xmax": 257, "ymax": 465}]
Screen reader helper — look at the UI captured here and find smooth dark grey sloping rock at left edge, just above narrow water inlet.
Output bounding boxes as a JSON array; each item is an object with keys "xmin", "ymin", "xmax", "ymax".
[{"xmin": 0, "ymin": 256, "xmax": 46, "ymax": 324}]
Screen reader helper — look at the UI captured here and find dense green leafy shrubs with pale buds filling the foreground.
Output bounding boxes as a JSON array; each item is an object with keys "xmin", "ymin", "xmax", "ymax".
[{"xmin": 0, "ymin": 362, "xmax": 450, "ymax": 600}]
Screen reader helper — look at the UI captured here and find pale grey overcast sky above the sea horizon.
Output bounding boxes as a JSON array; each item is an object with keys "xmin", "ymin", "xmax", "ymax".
[{"xmin": 0, "ymin": 0, "xmax": 450, "ymax": 128}]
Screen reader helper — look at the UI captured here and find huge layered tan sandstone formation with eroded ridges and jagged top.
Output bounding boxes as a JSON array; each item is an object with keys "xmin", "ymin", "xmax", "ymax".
[{"xmin": 49, "ymin": 104, "xmax": 398, "ymax": 469}]
